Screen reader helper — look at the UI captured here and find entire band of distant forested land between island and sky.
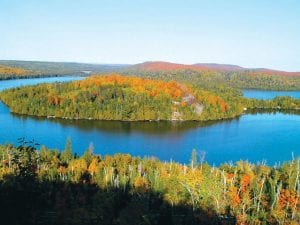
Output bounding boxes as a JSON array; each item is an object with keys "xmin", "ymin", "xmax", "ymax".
[{"xmin": 0, "ymin": 60, "xmax": 300, "ymax": 90}]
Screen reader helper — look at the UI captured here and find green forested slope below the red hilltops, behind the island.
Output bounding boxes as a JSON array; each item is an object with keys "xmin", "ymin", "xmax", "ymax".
[{"xmin": 120, "ymin": 67, "xmax": 300, "ymax": 90}]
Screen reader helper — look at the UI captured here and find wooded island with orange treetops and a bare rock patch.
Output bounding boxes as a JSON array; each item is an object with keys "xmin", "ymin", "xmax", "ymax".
[{"xmin": 0, "ymin": 74, "xmax": 243, "ymax": 121}]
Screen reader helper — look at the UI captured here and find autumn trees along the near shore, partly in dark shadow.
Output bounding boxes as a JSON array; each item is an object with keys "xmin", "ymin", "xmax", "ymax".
[{"xmin": 0, "ymin": 142, "xmax": 300, "ymax": 225}]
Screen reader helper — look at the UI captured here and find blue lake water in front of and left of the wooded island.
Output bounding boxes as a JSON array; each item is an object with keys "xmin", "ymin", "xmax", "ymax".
[{"xmin": 0, "ymin": 77, "xmax": 300, "ymax": 165}]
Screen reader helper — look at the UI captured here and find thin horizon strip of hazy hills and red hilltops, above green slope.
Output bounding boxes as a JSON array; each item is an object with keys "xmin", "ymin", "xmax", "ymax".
[{"xmin": 0, "ymin": 60, "xmax": 300, "ymax": 76}]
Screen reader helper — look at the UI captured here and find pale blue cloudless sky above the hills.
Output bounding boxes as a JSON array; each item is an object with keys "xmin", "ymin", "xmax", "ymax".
[{"xmin": 0, "ymin": 0, "xmax": 300, "ymax": 71}]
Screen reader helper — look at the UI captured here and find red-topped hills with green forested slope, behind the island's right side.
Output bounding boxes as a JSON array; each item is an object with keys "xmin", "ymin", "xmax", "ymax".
[{"xmin": 119, "ymin": 61, "xmax": 300, "ymax": 92}]
